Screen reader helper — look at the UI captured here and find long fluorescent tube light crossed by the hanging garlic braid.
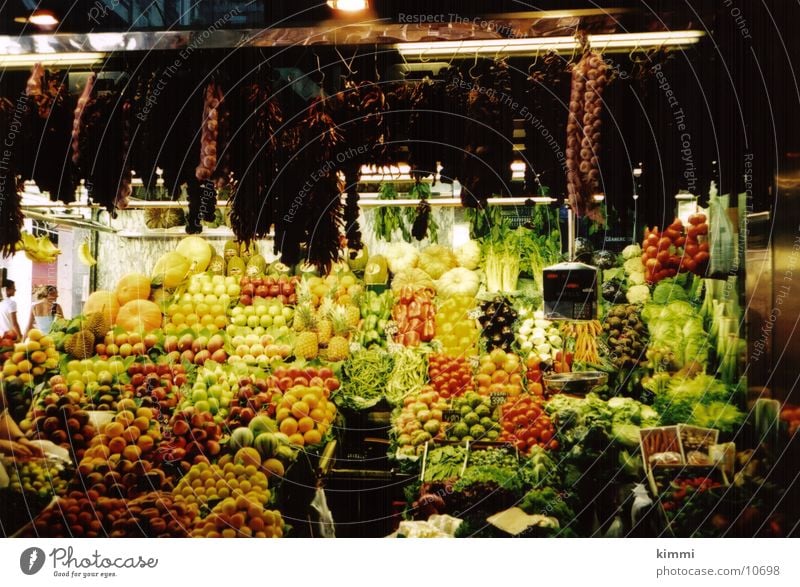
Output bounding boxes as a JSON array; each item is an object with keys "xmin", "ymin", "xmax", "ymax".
[{"xmin": 394, "ymin": 30, "xmax": 705, "ymax": 59}]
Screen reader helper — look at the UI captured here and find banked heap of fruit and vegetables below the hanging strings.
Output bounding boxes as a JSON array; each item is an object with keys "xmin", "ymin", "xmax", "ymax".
[{"xmin": 2, "ymin": 215, "xmax": 797, "ymax": 537}]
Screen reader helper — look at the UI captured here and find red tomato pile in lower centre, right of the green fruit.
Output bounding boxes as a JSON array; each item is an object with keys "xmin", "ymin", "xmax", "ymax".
[{"xmin": 498, "ymin": 395, "xmax": 558, "ymax": 454}]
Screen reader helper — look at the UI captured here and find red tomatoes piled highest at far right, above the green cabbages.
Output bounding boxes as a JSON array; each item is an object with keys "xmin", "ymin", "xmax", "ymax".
[{"xmin": 642, "ymin": 214, "xmax": 709, "ymax": 283}]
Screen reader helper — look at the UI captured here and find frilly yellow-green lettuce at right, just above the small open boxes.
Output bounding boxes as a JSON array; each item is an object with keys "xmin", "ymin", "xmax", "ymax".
[{"xmin": 653, "ymin": 373, "xmax": 744, "ymax": 432}]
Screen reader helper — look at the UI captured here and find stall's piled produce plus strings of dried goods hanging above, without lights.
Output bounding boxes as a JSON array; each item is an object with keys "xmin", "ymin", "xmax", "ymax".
[{"xmin": 0, "ymin": 27, "xmax": 800, "ymax": 537}]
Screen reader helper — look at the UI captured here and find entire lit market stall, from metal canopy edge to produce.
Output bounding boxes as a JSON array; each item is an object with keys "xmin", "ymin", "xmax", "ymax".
[{"xmin": 0, "ymin": 11, "xmax": 800, "ymax": 538}]
